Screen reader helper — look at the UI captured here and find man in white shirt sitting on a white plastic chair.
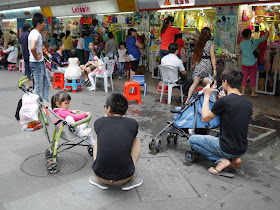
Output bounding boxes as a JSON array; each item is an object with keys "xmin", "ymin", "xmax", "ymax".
[{"xmin": 161, "ymin": 43, "xmax": 192, "ymax": 96}]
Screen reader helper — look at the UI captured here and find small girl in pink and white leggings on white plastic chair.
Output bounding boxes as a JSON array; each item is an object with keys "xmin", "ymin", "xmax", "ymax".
[{"xmin": 88, "ymin": 48, "xmax": 103, "ymax": 91}]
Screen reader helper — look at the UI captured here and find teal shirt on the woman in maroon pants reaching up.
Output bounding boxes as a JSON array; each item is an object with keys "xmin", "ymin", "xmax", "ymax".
[{"xmin": 240, "ymin": 37, "xmax": 266, "ymax": 66}]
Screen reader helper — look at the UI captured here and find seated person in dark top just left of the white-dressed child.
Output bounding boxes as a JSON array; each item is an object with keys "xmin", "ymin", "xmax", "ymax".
[{"xmin": 51, "ymin": 42, "xmax": 68, "ymax": 74}]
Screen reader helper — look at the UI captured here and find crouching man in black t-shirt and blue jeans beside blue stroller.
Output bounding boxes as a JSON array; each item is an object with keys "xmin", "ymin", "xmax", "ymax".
[{"xmin": 189, "ymin": 68, "xmax": 252, "ymax": 177}]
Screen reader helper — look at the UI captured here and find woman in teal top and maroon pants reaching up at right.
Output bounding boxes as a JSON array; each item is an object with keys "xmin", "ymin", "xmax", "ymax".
[{"xmin": 240, "ymin": 29, "xmax": 268, "ymax": 97}]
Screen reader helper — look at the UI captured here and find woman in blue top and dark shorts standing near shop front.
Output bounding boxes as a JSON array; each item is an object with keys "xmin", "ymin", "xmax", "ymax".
[{"xmin": 126, "ymin": 28, "xmax": 143, "ymax": 81}]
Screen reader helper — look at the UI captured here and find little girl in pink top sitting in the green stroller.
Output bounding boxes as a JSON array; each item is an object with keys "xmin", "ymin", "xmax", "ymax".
[{"xmin": 51, "ymin": 91, "xmax": 94, "ymax": 145}]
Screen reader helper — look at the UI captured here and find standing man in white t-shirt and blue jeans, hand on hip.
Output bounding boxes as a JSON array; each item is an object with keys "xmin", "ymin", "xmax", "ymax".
[{"xmin": 28, "ymin": 13, "xmax": 50, "ymax": 101}]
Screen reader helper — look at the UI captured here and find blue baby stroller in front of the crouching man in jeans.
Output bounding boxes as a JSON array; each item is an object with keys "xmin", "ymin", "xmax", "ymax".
[{"xmin": 149, "ymin": 86, "xmax": 222, "ymax": 161}]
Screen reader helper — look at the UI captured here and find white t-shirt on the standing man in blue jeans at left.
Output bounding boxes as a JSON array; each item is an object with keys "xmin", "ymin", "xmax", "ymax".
[{"xmin": 28, "ymin": 29, "xmax": 44, "ymax": 62}]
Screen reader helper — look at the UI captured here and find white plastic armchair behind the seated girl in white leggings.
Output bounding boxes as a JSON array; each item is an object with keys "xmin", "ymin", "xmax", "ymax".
[{"xmin": 95, "ymin": 60, "xmax": 116, "ymax": 93}]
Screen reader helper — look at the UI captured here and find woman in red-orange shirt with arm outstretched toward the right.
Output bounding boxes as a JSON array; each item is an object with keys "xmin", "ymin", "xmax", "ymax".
[{"xmin": 159, "ymin": 16, "xmax": 198, "ymax": 59}]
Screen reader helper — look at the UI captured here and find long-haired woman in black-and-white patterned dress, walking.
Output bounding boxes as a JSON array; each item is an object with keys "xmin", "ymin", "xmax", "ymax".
[{"xmin": 186, "ymin": 27, "xmax": 217, "ymax": 103}]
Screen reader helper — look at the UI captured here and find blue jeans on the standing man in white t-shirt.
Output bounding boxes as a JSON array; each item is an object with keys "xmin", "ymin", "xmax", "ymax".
[{"xmin": 29, "ymin": 62, "xmax": 51, "ymax": 101}]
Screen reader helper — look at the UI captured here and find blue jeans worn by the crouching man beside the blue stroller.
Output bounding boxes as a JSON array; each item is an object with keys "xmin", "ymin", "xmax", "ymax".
[{"xmin": 189, "ymin": 135, "xmax": 245, "ymax": 164}]
